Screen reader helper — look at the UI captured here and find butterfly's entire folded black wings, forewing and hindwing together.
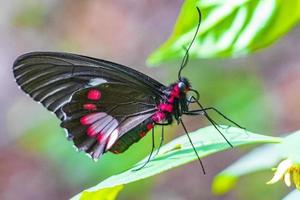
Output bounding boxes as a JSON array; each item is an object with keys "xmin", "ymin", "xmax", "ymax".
[{"xmin": 13, "ymin": 52, "xmax": 166, "ymax": 159}]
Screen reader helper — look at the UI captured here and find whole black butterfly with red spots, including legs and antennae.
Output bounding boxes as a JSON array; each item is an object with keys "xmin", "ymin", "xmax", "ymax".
[{"xmin": 13, "ymin": 7, "xmax": 238, "ymax": 172}]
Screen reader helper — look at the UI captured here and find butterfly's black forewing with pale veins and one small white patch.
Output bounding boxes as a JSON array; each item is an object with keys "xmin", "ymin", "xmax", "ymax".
[{"xmin": 13, "ymin": 52, "xmax": 166, "ymax": 120}]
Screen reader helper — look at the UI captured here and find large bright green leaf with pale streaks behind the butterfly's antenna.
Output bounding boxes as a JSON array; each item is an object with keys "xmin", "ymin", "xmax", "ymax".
[{"xmin": 147, "ymin": 0, "xmax": 300, "ymax": 65}]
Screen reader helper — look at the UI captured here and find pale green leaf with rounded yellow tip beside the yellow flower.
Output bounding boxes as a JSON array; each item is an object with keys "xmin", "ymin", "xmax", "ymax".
[{"xmin": 212, "ymin": 131, "xmax": 300, "ymax": 195}]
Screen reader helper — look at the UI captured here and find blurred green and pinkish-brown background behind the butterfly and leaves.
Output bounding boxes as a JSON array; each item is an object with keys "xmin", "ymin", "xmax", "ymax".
[{"xmin": 0, "ymin": 0, "xmax": 300, "ymax": 200}]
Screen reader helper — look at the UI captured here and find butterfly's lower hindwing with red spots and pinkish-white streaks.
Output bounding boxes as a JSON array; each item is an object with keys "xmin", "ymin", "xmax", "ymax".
[{"xmin": 61, "ymin": 82, "xmax": 157, "ymax": 159}]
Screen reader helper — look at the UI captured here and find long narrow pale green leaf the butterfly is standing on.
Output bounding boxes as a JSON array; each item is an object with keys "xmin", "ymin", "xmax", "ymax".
[{"xmin": 76, "ymin": 126, "xmax": 281, "ymax": 198}]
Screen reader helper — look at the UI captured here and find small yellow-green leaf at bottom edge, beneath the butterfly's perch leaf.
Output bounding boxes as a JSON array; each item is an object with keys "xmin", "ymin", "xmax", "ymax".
[{"xmin": 80, "ymin": 185, "xmax": 123, "ymax": 200}]
